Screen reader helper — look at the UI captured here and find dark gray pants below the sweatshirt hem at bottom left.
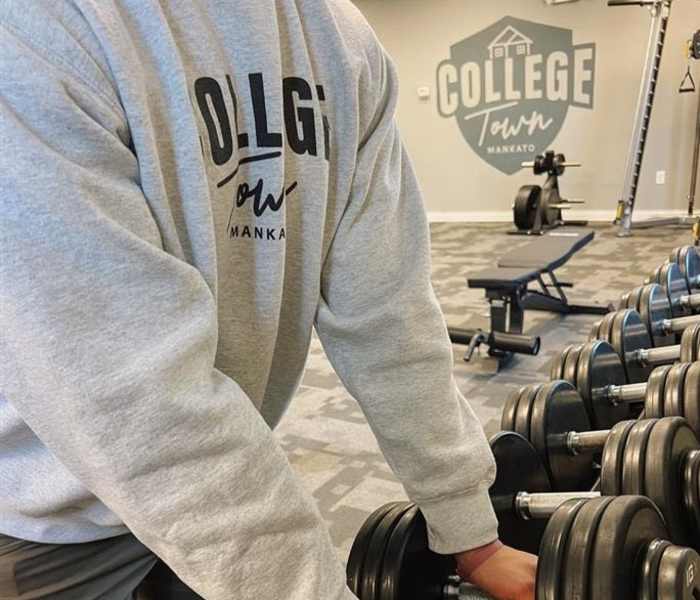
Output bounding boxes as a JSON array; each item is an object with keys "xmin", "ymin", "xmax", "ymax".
[{"xmin": 0, "ymin": 535, "xmax": 202, "ymax": 600}]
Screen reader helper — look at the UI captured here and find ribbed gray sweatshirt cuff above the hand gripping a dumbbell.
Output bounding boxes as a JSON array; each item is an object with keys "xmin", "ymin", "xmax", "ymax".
[{"xmin": 419, "ymin": 484, "xmax": 498, "ymax": 554}]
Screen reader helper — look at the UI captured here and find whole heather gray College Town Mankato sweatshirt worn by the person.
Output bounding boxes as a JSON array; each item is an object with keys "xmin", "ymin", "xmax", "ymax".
[{"xmin": 0, "ymin": 0, "xmax": 496, "ymax": 600}]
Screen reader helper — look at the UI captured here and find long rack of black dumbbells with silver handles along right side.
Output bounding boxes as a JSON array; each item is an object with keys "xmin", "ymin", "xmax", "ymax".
[{"xmin": 347, "ymin": 246, "xmax": 700, "ymax": 600}]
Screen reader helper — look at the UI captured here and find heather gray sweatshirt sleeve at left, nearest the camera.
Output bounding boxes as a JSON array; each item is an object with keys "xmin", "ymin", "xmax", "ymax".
[{"xmin": 0, "ymin": 23, "xmax": 354, "ymax": 600}]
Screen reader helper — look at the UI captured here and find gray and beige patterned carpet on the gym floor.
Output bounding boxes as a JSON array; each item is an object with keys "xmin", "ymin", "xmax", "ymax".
[{"xmin": 277, "ymin": 223, "xmax": 691, "ymax": 557}]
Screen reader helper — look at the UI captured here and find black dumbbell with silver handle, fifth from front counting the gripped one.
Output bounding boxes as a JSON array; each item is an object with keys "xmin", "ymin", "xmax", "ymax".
[{"xmin": 590, "ymin": 309, "xmax": 700, "ymax": 383}]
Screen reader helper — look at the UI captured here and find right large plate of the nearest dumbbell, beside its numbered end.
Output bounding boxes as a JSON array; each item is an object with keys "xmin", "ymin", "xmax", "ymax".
[{"xmin": 590, "ymin": 496, "xmax": 668, "ymax": 600}]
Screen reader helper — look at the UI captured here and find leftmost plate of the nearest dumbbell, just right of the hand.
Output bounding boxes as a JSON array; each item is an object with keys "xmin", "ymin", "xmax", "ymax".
[{"xmin": 535, "ymin": 500, "xmax": 586, "ymax": 600}]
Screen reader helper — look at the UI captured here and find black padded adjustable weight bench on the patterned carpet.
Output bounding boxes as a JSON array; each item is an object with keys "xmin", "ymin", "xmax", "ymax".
[{"xmin": 449, "ymin": 228, "xmax": 613, "ymax": 367}]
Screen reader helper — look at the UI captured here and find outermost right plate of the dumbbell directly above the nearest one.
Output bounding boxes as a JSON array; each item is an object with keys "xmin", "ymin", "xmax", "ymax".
[{"xmin": 645, "ymin": 417, "xmax": 699, "ymax": 546}]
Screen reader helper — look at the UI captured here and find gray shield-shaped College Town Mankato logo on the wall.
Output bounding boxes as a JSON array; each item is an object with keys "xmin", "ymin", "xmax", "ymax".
[{"xmin": 437, "ymin": 17, "xmax": 596, "ymax": 175}]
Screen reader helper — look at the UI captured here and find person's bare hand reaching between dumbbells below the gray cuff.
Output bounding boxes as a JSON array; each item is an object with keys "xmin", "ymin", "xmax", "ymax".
[{"xmin": 455, "ymin": 546, "xmax": 537, "ymax": 600}]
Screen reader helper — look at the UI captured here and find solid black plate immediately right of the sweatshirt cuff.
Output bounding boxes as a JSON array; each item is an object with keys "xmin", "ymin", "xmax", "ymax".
[{"xmin": 489, "ymin": 431, "xmax": 552, "ymax": 554}]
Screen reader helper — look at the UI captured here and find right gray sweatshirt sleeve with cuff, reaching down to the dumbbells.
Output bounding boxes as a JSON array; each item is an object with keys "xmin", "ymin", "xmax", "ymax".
[{"xmin": 316, "ymin": 45, "xmax": 497, "ymax": 554}]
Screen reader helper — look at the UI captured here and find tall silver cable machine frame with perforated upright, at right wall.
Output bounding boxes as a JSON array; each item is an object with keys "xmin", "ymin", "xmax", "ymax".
[{"xmin": 608, "ymin": 0, "xmax": 700, "ymax": 237}]
